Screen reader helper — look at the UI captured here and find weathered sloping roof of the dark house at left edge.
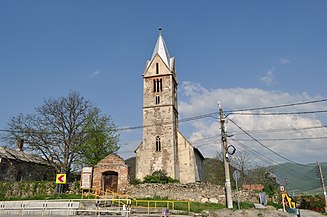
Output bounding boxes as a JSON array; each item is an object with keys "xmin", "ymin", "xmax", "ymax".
[{"xmin": 0, "ymin": 147, "xmax": 48, "ymax": 165}]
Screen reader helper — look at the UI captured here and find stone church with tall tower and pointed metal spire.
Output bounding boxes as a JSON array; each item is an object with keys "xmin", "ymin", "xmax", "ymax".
[{"xmin": 135, "ymin": 29, "xmax": 204, "ymax": 183}]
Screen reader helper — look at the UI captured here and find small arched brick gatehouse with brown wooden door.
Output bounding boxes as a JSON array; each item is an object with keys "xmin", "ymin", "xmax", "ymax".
[{"xmin": 92, "ymin": 154, "xmax": 129, "ymax": 193}]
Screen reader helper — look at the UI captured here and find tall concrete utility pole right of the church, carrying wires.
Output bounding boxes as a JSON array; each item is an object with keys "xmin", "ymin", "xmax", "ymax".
[{"xmin": 218, "ymin": 102, "xmax": 233, "ymax": 209}]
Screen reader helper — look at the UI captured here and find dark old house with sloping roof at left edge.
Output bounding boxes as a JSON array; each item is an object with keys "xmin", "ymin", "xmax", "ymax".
[{"xmin": 0, "ymin": 146, "xmax": 55, "ymax": 182}]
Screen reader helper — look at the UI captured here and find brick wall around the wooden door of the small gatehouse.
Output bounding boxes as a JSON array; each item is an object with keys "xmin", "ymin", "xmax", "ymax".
[{"xmin": 92, "ymin": 154, "xmax": 129, "ymax": 192}]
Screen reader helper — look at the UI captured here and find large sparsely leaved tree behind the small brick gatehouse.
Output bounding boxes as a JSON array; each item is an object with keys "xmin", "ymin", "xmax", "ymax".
[{"xmin": 3, "ymin": 91, "xmax": 119, "ymax": 174}]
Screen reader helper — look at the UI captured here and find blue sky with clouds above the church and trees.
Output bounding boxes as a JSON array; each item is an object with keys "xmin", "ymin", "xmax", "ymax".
[{"xmin": 0, "ymin": 0, "xmax": 327, "ymax": 164}]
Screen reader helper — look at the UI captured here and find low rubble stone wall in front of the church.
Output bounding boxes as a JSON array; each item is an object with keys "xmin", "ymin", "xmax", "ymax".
[{"xmin": 125, "ymin": 183, "xmax": 259, "ymax": 204}]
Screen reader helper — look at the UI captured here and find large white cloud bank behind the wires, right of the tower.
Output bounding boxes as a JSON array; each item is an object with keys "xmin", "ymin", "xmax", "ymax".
[{"xmin": 179, "ymin": 81, "xmax": 327, "ymax": 163}]
